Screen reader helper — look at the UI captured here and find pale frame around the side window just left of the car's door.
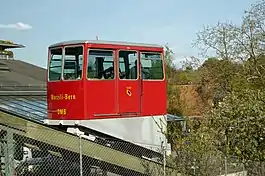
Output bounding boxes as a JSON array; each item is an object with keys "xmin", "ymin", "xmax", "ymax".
[{"xmin": 86, "ymin": 48, "xmax": 117, "ymax": 81}]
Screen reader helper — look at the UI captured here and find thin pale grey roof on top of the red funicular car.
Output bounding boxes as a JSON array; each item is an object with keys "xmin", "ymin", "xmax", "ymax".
[{"xmin": 50, "ymin": 40, "xmax": 163, "ymax": 48}]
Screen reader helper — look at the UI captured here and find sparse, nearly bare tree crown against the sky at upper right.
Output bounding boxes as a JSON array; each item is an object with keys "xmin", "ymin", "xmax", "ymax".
[{"xmin": 193, "ymin": 0, "xmax": 265, "ymax": 91}]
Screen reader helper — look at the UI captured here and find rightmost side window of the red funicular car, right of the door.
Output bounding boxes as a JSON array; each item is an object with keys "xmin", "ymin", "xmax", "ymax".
[{"xmin": 140, "ymin": 52, "xmax": 164, "ymax": 80}]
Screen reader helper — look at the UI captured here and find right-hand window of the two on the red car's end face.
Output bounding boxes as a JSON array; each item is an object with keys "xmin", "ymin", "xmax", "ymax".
[{"xmin": 63, "ymin": 46, "xmax": 83, "ymax": 80}]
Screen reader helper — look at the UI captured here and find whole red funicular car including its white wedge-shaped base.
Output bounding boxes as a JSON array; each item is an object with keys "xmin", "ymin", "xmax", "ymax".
[{"xmin": 44, "ymin": 40, "xmax": 167, "ymax": 153}]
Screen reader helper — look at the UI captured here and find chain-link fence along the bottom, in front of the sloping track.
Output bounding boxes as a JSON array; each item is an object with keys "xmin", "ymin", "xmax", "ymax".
[{"xmin": 0, "ymin": 117, "xmax": 252, "ymax": 176}]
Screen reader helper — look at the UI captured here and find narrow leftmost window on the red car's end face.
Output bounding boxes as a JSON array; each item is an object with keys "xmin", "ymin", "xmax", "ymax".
[{"xmin": 48, "ymin": 48, "xmax": 63, "ymax": 81}]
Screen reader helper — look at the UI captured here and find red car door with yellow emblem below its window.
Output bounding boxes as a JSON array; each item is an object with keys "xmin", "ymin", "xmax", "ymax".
[{"xmin": 117, "ymin": 50, "xmax": 141, "ymax": 115}]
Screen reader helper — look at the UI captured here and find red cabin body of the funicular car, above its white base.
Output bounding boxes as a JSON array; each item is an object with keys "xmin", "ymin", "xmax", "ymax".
[{"xmin": 47, "ymin": 41, "xmax": 167, "ymax": 120}]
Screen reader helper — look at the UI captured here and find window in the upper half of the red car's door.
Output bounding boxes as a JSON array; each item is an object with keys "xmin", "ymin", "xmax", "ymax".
[{"xmin": 119, "ymin": 51, "xmax": 138, "ymax": 79}]
